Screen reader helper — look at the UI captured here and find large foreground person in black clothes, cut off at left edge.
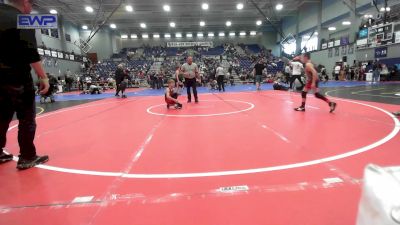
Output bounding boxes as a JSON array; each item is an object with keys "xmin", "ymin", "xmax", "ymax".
[{"xmin": 0, "ymin": 0, "xmax": 49, "ymax": 170}]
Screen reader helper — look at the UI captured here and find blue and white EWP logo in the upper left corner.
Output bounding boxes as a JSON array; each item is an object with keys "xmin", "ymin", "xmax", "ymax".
[{"xmin": 17, "ymin": 14, "xmax": 58, "ymax": 29}]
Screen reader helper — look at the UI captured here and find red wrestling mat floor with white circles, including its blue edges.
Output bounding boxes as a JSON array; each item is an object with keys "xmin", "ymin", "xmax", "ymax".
[{"xmin": 0, "ymin": 82, "xmax": 400, "ymax": 225}]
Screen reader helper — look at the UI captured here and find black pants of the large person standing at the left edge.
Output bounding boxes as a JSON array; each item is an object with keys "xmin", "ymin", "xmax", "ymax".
[{"xmin": 0, "ymin": 85, "xmax": 36, "ymax": 159}]
